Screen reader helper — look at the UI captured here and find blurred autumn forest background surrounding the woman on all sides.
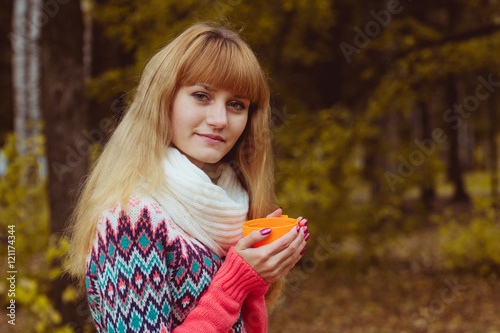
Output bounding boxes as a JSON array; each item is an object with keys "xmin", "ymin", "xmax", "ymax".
[{"xmin": 0, "ymin": 0, "xmax": 500, "ymax": 332}]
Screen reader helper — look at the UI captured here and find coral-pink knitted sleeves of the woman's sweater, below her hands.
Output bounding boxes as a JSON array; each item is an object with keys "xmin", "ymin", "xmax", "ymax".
[{"xmin": 172, "ymin": 248, "xmax": 269, "ymax": 333}]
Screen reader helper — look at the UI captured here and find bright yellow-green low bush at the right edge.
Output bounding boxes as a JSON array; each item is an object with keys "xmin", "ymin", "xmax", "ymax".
[{"xmin": 439, "ymin": 199, "xmax": 500, "ymax": 274}]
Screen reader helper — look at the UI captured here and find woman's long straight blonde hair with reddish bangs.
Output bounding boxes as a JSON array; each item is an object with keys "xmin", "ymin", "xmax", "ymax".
[{"xmin": 67, "ymin": 23, "xmax": 283, "ymax": 308}]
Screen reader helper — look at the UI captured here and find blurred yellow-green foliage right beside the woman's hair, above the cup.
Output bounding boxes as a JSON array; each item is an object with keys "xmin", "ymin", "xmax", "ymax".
[{"xmin": 274, "ymin": 106, "xmax": 403, "ymax": 240}]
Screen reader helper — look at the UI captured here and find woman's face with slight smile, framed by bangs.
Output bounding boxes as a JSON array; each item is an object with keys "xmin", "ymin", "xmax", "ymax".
[{"xmin": 171, "ymin": 83, "xmax": 250, "ymax": 168}]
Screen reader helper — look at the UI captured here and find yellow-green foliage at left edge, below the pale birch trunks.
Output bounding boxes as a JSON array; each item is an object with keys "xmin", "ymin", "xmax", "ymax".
[{"xmin": 0, "ymin": 134, "xmax": 82, "ymax": 333}]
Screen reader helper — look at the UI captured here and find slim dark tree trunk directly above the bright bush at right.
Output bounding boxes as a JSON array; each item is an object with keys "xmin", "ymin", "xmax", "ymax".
[{"xmin": 447, "ymin": 74, "xmax": 470, "ymax": 202}]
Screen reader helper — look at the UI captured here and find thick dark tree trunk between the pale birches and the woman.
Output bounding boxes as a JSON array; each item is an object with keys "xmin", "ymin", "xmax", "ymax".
[{"xmin": 42, "ymin": 0, "xmax": 89, "ymax": 331}]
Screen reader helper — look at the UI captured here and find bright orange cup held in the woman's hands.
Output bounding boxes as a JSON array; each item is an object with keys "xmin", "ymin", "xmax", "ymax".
[{"xmin": 243, "ymin": 215, "xmax": 299, "ymax": 247}]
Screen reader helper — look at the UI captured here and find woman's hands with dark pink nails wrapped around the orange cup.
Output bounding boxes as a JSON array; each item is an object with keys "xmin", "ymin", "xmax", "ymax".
[{"xmin": 234, "ymin": 208, "xmax": 309, "ymax": 283}]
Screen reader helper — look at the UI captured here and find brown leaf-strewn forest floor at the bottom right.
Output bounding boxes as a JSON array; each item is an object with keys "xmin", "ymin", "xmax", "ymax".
[{"xmin": 269, "ymin": 258, "xmax": 500, "ymax": 333}]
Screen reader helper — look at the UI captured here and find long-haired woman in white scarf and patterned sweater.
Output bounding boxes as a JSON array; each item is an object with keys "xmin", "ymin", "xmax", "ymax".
[{"xmin": 66, "ymin": 24, "xmax": 309, "ymax": 332}]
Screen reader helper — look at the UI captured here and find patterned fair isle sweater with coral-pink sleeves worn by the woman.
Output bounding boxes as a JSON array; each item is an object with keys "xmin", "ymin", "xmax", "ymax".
[{"xmin": 86, "ymin": 196, "xmax": 268, "ymax": 333}]
